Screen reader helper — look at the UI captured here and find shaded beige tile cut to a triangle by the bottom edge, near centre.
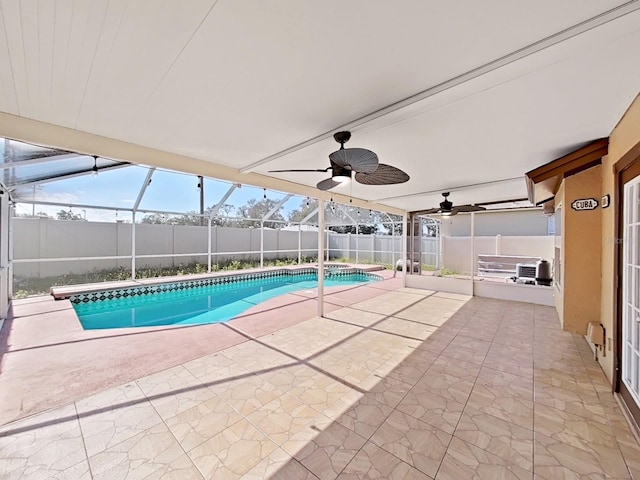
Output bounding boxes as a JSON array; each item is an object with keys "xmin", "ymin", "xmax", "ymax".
[{"xmin": 337, "ymin": 442, "xmax": 431, "ymax": 480}]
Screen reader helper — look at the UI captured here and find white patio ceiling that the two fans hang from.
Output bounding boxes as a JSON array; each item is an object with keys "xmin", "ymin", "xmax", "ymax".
[{"xmin": 0, "ymin": 0, "xmax": 640, "ymax": 210}]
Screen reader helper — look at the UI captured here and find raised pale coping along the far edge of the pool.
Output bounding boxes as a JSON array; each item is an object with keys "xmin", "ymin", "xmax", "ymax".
[{"xmin": 49, "ymin": 262, "xmax": 384, "ymax": 300}]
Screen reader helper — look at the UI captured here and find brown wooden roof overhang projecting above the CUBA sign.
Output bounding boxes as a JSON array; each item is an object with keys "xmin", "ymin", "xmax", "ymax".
[{"xmin": 525, "ymin": 138, "xmax": 609, "ymax": 205}]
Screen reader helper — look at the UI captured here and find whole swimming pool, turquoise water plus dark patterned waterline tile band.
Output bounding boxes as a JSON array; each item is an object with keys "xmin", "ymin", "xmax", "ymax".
[{"xmin": 70, "ymin": 268, "xmax": 382, "ymax": 330}]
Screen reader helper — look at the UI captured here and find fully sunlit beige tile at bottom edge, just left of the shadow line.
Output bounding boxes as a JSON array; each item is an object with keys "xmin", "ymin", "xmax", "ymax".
[{"xmin": 188, "ymin": 420, "xmax": 277, "ymax": 480}]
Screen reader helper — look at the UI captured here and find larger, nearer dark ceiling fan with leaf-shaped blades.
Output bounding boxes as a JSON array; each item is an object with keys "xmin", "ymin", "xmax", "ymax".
[{"xmin": 269, "ymin": 131, "xmax": 410, "ymax": 190}]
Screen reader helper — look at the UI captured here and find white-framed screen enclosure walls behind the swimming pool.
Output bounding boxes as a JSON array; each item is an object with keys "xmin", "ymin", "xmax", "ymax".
[{"xmin": 0, "ymin": 139, "xmax": 424, "ymax": 306}]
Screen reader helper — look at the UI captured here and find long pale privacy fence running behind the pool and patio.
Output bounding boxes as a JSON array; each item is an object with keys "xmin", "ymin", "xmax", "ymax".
[{"xmin": 12, "ymin": 217, "xmax": 553, "ymax": 277}]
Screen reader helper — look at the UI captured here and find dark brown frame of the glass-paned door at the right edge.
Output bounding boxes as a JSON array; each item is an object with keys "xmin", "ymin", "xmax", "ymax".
[{"xmin": 612, "ymin": 142, "xmax": 640, "ymax": 427}]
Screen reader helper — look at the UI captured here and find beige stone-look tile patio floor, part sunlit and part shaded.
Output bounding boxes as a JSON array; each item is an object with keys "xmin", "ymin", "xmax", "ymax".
[{"xmin": 0, "ymin": 289, "xmax": 640, "ymax": 480}]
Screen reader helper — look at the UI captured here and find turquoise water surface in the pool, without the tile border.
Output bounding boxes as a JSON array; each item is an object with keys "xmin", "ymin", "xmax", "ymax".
[{"xmin": 72, "ymin": 273, "xmax": 379, "ymax": 330}]
